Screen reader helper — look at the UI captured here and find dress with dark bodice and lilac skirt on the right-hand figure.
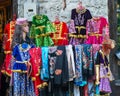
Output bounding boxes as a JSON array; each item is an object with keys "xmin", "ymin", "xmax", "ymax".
[{"xmin": 96, "ymin": 50, "xmax": 113, "ymax": 95}]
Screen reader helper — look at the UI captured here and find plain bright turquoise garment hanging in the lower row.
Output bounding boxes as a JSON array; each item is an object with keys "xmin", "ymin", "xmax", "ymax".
[{"xmin": 40, "ymin": 47, "xmax": 50, "ymax": 81}]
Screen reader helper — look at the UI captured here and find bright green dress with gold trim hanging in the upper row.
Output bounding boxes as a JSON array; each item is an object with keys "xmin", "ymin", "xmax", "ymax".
[{"xmin": 30, "ymin": 15, "xmax": 56, "ymax": 47}]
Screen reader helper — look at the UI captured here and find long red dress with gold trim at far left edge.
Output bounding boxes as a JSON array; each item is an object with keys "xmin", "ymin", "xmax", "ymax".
[{"xmin": 2, "ymin": 21, "xmax": 16, "ymax": 76}]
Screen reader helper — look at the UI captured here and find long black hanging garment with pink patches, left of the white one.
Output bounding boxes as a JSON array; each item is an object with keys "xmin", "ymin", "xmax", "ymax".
[{"xmin": 53, "ymin": 46, "xmax": 69, "ymax": 96}]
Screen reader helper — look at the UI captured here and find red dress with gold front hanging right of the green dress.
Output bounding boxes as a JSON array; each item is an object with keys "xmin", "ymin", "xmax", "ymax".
[{"xmin": 51, "ymin": 22, "xmax": 68, "ymax": 45}]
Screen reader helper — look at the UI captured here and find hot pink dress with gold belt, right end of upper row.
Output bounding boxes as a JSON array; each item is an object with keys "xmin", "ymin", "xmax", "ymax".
[{"xmin": 86, "ymin": 17, "xmax": 109, "ymax": 44}]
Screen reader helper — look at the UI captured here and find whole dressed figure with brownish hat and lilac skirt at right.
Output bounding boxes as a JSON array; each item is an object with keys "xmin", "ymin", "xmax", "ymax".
[{"xmin": 95, "ymin": 38, "xmax": 115, "ymax": 95}]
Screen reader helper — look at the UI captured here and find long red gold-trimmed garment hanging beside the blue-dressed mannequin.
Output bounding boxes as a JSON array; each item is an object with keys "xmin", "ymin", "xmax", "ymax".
[{"xmin": 29, "ymin": 48, "xmax": 47, "ymax": 96}]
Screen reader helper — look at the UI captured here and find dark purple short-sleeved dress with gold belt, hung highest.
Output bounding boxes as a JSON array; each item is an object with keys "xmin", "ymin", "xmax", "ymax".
[{"xmin": 69, "ymin": 9, "xmax": 92, "ymax": 44}]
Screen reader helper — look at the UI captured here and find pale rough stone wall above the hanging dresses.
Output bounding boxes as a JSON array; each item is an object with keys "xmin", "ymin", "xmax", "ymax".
[{"xmin": 18, "ymin": 0, "xmax": 108, "ymax": 22}]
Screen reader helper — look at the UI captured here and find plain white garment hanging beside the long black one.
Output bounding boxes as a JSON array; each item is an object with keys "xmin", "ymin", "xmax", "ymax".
[{"xmin": 65, "ymin": 45, "xmax": 76, "ymax": 81}]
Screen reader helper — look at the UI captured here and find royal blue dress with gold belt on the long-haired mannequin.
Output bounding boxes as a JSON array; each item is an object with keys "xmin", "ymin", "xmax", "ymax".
[{"xmin": 12, "ymin": 43, "xmax": 35, "ymax": 96}]
